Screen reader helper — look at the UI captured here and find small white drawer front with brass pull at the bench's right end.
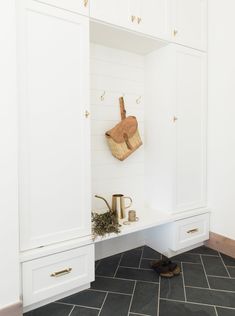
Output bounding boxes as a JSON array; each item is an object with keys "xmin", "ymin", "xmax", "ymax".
[{"xmin": 172, "ymin": 214, "xmax": 210, "ymax": 251}]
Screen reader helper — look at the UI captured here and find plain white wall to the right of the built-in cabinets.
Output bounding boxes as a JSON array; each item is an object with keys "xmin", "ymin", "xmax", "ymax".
[{"xmin": 208, "ymin": 0, "xmax": 235, "ymax": 239}]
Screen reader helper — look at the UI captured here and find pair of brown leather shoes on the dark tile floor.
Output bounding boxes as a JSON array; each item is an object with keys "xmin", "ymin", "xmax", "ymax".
[{"xmin": 151, "ymin": 259, "xmax": 181, "ymax": 278}]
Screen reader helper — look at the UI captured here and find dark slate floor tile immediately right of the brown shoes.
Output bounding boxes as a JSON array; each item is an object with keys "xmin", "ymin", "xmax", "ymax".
[{"xmin": 183, "ymin": 263, "xmax": 208, "ymax": 288}]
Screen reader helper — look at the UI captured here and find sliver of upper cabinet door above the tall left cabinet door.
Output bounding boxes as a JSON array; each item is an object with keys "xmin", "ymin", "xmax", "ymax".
[{"xmin": 36, "ymin": 0, "xmax": 90, "ymax": 16}]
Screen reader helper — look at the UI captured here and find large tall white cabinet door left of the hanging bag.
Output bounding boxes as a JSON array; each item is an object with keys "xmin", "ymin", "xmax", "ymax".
[{"xmin": 19, "ymin": 1, "xmax": 91, "ymax": 250}]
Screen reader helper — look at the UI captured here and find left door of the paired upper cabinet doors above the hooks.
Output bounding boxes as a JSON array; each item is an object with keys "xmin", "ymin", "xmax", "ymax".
[{"xmin": 90, "ymin": 0, "xmax": 131, "ymax": 27}]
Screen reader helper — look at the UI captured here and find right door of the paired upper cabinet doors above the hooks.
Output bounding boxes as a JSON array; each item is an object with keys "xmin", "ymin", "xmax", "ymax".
[{"xmin": 137, "ymin": 0, "xmax": 170, "ymax": 40}]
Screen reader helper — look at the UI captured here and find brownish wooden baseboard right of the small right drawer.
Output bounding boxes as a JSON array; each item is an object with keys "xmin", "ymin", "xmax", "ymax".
[{"xmin": 205, "ymin": 232, "xmax": 235, "ymax": 258}]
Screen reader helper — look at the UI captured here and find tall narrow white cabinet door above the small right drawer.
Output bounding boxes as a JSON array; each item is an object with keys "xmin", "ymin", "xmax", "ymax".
[{"xmin": 174, "ymin": 47, "xmax": 207, "ymax": 211}]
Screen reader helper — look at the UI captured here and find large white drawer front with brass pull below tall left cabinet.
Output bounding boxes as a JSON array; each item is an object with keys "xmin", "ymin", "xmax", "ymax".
[{"xmin": 22, "ymin": 245, "xmax": 94, "ymax": 306}]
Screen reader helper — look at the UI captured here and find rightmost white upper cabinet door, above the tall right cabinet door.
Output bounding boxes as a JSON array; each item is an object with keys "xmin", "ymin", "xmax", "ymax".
[{"xmin": 171, "ymin": 0, "xmax": 207, "ymax": 50}]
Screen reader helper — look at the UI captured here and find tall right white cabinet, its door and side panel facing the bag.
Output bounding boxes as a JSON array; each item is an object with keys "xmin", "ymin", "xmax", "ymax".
[{"xmin": 145, "ymin": 44, "xmax": 207, "ymax": 212}]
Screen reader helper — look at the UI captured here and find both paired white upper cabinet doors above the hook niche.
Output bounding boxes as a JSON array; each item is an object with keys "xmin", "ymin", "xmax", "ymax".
[{"xmin": 90, "ymin": 0, "xmax": 169, "ymax": 39}]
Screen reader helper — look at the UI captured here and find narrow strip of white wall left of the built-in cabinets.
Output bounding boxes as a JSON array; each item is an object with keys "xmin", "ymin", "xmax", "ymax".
[{"xmin": 0, "ymin": 0, "xmax": 19, "ymax": 310}]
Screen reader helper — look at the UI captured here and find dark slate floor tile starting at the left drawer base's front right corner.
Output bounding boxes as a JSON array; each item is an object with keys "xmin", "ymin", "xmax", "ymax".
[{"xmin": 91, "ymin": 276, "xmax": 135, "ymax": 294}]
